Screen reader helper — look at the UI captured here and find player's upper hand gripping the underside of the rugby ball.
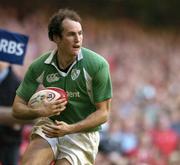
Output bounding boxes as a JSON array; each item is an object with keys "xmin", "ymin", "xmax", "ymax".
[{"xmin": 35, "ymin": 98, "xmax": 67, "ymax": 117}]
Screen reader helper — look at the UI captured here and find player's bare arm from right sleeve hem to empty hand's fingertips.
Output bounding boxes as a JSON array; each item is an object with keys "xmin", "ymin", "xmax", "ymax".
[{"xmin": 43, "ymin": 99, "xmax": 111, "ymax": 137}]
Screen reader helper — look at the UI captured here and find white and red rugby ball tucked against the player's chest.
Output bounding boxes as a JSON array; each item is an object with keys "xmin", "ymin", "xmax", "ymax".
[{"xmin": 28, "ymin": 87, "xmax": 68, "ymax": 108}]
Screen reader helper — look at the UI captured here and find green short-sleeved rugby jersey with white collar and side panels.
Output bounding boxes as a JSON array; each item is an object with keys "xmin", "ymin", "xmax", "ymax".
[{"xmin": 16, "ymin": 48, "xmax": 112, "ymax": 131}]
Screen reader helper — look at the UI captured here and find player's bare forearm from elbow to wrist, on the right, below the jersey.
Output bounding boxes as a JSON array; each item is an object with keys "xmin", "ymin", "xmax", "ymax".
[{"xmin": 70, "ymin": 110, "xmax": 109, "ymax": 133}]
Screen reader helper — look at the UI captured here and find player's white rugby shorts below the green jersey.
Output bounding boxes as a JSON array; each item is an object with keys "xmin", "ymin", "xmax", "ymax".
[{"xmin": 31, "ymin": 118, "xmax": 100, "ymax": 165}]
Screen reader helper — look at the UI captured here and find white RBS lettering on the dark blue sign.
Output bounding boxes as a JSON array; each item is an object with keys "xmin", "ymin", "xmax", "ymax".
[{"xmin": 0, "ymin": 39, "xmax": 25, "ymax": 56}]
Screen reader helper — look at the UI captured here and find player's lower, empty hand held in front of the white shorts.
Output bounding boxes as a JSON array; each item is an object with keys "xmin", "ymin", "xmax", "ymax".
[{"xmin": 42, "ymin": 121, "xmax": 71, "ymax": 138}]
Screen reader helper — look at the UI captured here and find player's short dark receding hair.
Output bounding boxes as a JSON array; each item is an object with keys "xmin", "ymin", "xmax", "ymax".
[{"xmin": 48, "ymin": 9, "xmax": 81, "ymax": 41}]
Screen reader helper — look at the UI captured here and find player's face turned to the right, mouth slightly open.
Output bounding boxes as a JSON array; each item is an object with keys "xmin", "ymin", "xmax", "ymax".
[{"xmin": 58, "ymin": 19, "xmax": 83, "ymax": 56}]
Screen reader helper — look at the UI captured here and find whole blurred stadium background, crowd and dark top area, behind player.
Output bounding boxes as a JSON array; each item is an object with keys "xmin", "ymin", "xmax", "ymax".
[{"xmin": 0, "ymin": 0, "xmax": 180, "ymax": 165}]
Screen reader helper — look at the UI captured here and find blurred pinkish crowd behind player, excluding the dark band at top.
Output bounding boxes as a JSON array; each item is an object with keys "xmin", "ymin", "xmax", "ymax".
[{"xmin": 0, "ymin": 8, "xmax": 180, "ymax": 165}]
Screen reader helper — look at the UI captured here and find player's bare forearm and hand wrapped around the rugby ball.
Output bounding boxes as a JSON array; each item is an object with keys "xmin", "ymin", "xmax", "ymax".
[{"xmin": 13, "ymin": 95, "xmax": 67, "ymax": 120}]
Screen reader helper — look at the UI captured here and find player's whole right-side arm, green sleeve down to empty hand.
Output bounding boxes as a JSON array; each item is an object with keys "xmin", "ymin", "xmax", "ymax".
[{"xmin": 43, "ymin": 58, "xmax": 112, "ymax": 137}]
